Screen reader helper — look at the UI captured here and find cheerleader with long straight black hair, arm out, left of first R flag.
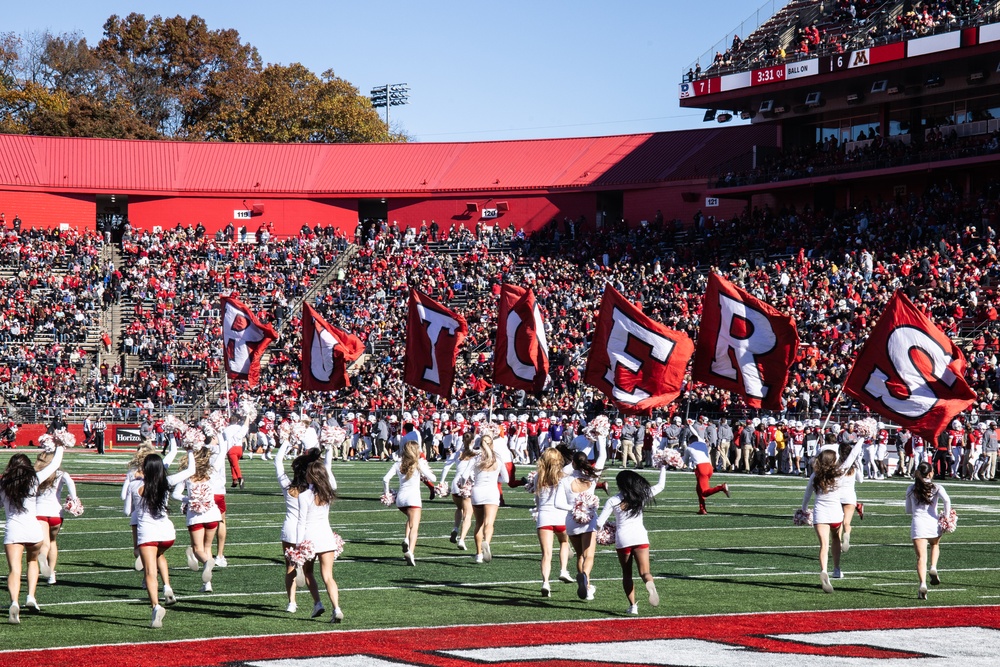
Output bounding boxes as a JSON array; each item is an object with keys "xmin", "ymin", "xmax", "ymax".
[{"xmin": 130, "ymin": 453, "xmax": 195, "ymax": 628}]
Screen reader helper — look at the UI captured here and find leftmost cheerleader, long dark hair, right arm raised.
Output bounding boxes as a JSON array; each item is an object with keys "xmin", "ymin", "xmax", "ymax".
[{"xmin": 0, "ymin": 447, "xmax": 63, "ymax": 623}]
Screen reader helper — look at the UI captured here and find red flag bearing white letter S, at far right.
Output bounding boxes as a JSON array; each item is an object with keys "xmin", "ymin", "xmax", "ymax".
[{"xmin": 844, "ymin": 291, "xmax": 976, "ymax": 441}]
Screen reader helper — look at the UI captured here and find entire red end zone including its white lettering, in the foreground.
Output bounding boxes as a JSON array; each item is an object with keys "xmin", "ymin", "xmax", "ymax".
[{"xmin": 0, "ymin": 606, "xmax": 1000, "ymax": 667}]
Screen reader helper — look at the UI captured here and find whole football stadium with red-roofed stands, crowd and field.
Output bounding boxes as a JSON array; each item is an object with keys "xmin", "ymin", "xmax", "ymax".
[{"xmin": 0, "ymin": 0, "xmax": 1000, "ymax": 667}]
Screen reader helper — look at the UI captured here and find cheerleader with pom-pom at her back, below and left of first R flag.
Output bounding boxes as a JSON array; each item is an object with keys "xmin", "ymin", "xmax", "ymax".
[{"xmin": 174, "ymin": 448, "xmax": 222, "ymax": 593}]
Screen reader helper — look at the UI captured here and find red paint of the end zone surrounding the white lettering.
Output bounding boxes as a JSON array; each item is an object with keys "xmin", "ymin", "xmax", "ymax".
[{"xmin": 7, "ymin": 606, "xmax": 1000, "ymax": 667}]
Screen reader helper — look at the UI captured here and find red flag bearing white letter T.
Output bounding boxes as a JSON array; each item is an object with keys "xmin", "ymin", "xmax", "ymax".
[{"xmin": 403, "ymin": 289, "xmax": 469, "ymax": 399}]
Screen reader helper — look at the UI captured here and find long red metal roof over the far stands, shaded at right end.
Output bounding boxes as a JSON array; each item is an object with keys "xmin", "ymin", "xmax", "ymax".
[{"xmin": 0, "ymin": 126, "xmax": 775, "ymax": 196}]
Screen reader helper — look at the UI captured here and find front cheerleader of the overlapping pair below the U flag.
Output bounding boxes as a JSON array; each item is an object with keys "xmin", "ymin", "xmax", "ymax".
[{"xmin": 295, "ymin": 449, "xmax": 344, "ymax": 623}]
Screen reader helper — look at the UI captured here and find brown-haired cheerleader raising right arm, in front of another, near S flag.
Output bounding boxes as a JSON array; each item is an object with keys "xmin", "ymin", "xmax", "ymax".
[{"xmin": 802, "ymin": 440, "xmax": 864, "ymax": 593}]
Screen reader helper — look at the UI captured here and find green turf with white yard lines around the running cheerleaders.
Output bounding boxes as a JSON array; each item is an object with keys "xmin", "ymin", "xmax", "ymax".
[{"xmin": 0, "ymin": 453, "xmax": 1000, "ymax": 649}]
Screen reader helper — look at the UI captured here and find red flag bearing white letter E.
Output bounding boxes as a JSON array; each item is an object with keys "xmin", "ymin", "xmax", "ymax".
[{"xmin": 583, "ymin": 285, "xmax": 694, "ymax": 414}]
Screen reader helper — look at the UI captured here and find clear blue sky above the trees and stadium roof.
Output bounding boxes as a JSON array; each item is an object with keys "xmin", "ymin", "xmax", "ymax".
[{"xmin": 0, "ymin": 0, "xmax": 764, "ymax": 141}]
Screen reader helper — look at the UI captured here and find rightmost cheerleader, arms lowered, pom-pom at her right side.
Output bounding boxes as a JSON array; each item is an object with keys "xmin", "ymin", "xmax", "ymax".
[{"xmin": 906, "ymin": 462, "xmax": 951, "ymax": 600}]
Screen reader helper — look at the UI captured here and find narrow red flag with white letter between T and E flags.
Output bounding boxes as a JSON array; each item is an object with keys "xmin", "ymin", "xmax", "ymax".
[{"xmin": 493, "ymin": 285, "xmax": 549, "ymax": 394}]
